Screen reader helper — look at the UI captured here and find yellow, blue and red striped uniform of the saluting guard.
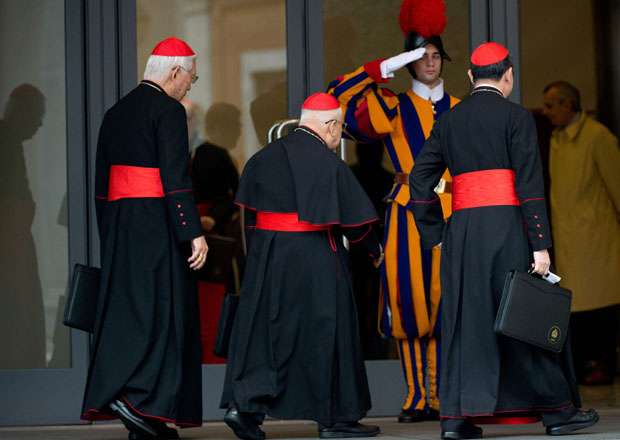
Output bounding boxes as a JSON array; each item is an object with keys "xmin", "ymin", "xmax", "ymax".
[{"xmin": 328, "ymin": 60, "xmax": 458, "ymax": 410}]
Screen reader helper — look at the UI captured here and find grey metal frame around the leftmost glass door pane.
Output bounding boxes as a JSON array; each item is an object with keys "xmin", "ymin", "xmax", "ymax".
[{"xmin": 0, "ymin": 0, "xmax": 89, "ymax": 426}]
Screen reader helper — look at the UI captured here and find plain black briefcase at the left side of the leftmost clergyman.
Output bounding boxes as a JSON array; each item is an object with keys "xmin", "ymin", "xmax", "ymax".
[{"xmin": 63, "ymin": 264, "xmax": 101, "ymax": 333}]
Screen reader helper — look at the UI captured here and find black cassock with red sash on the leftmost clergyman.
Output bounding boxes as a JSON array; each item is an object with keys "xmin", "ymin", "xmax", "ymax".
[{"xmin": 82, "ymin": 81, "xmax": 202, "ymax": 426}]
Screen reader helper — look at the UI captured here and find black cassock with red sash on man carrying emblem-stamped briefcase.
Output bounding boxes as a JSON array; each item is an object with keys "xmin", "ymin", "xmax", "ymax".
[{"xmin": 410, "ymin": 87, "xmax": 580, "ymax": 417}]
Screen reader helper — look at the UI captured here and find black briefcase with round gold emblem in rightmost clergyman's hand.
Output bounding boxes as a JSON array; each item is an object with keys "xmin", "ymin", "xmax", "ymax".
[{"xmin": 494, "ymin": 271, "xmax": 572, "ymax": 353}]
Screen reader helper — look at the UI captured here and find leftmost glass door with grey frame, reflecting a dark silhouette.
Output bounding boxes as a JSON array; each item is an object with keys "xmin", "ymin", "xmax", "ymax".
[{"xmin": 0, "ymin": 0, "xmax": 87, "ymax": 425}]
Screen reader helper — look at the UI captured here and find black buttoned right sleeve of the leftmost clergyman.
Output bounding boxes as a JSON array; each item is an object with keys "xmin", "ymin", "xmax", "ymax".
[{"xmin": 157, "ymin": 104, "xmax": 202, "ymax": 242}]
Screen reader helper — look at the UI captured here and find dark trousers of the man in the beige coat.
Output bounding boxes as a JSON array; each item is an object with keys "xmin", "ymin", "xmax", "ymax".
[{"xmin": 570, "ymin": 306, "xmax": 620, "ymax": 381}]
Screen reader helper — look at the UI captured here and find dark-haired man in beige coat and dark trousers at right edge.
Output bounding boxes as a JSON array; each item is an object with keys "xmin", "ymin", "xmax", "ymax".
[{"xmin": 543, "ymin": 81, "xmax": 620, "ymax": 384}]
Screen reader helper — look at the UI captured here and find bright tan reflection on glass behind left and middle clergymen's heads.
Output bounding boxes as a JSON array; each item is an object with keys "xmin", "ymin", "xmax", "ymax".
[{"xmin": 137, "ymin": 0, "xmax": 287, "ymax": 168}]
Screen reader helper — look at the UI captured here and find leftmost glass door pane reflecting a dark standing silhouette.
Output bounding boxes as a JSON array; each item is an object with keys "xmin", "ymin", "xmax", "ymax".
[{"xmin": 0, "ymin": 0, "xmax": 71, "ymax": 369}]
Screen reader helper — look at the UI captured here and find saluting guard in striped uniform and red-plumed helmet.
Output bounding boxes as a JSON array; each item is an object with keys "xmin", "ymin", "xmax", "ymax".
[{"xmin": 329, "ymin": 0, "xmax": 458, "ymax": 423}]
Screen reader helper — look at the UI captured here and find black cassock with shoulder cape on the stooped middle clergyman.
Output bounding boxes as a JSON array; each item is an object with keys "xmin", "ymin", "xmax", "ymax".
[{"xmin": 221, "ymin": 127, "xmax": 380, "ymax": 425}]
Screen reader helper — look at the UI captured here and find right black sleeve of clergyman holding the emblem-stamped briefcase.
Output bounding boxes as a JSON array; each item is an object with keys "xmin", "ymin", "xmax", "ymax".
[{"xmin": 510, "ymin": 109, "xmax": 551, "ymax": 251}]
